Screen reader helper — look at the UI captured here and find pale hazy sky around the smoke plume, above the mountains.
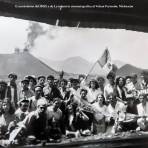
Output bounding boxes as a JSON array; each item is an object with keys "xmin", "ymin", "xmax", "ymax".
[{"xmin": 0, "ymin": 17, "xmax": 148, "ymax": 68}]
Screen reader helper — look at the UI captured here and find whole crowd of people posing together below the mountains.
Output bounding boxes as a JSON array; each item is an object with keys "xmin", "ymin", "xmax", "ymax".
[{"xmin": 0, "ymin": 71, "xmax": 148, "ymax": 145}]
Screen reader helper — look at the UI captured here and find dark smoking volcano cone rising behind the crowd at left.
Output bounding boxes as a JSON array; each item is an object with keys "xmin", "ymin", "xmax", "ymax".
[{"xmin": 0, "ymin": 52, "xmax": 58, "ymax": 78}]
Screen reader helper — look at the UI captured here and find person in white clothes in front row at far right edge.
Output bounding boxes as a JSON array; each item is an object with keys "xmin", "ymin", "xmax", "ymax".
[{"xmin": 137, "ymin": 95, "xmax": 148, "ymax": 131}]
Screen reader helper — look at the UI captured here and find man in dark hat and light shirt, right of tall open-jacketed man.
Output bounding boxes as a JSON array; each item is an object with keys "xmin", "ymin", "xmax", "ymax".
[{"xmin": 18, "ymin": 78, "xmax": 34, "ymax": 101}]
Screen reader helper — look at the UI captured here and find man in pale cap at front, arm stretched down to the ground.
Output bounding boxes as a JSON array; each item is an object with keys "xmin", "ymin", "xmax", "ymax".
[{"xmin": 9, "ymin": 99, "xmax": 47, "ymax": 143}]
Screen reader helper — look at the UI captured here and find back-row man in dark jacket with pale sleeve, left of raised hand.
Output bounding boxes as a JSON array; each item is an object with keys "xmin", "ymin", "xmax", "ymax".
[{"xmin": 43, "ymin": 75, "xmax": 63, "ymax": 100}]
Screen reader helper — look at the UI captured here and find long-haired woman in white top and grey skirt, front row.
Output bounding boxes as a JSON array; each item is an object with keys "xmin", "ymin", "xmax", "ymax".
[{"xmin": 92, "ymin": 94, "xmax": 107, "ymax": 134}]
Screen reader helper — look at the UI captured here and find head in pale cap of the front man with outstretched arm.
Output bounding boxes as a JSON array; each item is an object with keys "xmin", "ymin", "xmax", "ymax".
[{"xmin": 37, "ymin": 98, "xmax": 48, "ymax": 115}]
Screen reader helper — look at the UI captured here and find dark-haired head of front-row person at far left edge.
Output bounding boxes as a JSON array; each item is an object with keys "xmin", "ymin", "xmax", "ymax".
[{"xmin": 2, "ymin": 98, "xmax": 14, "ymax": 114}]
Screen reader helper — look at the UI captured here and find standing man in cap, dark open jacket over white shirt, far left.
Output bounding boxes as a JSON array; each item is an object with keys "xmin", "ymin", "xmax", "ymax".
[{"xmin": 8, "ymin": 73, "xmax": 17, "ymax": 108}]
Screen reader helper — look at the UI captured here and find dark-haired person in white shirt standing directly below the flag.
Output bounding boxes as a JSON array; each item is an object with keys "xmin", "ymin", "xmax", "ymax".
[{"xmin": 104, "ymin": 71, "xmax": 116, "ymax": 100}]
